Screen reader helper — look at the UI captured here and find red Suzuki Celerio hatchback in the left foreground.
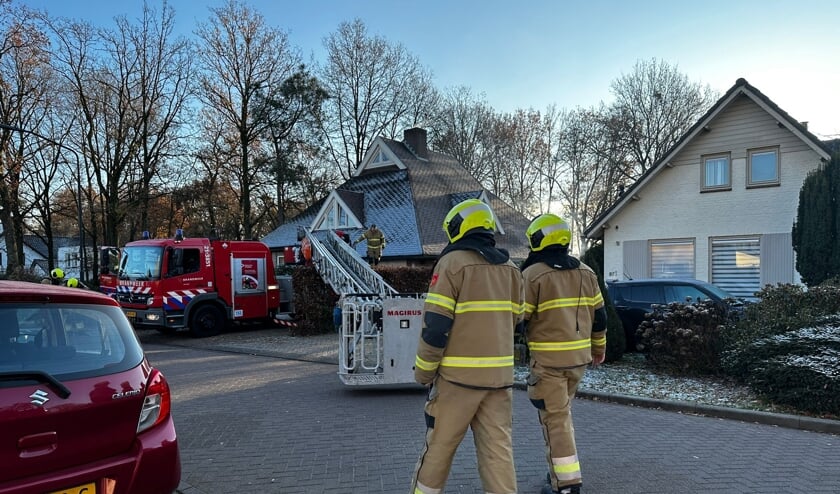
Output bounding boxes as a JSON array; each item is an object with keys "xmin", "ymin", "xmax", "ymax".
[{"xmin": 0, "ymin": 281, "xmax": 181, "ymax": 494}]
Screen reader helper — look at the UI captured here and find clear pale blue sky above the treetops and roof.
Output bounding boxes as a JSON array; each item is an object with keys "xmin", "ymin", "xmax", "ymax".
[{"xmin": 18, "ymin": 0, "xmax": 840, "ymax": 138}]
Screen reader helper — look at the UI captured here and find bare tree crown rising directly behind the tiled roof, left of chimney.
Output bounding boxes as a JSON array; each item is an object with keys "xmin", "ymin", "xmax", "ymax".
[{"xmin": 320, "ymin": 19, "xmax": 435, "ymax": 177}]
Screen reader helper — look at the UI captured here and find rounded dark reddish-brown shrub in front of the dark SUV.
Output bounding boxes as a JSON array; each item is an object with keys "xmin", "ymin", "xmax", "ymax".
[{"xmin": 636, "ymin": 300, "xmax": 735, "ymax": 374}]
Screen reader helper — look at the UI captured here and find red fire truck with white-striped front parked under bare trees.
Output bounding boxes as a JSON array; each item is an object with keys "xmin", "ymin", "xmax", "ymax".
[{"xmin": 99, "ymin": 230, "xmax": 291, "ymax": 337}]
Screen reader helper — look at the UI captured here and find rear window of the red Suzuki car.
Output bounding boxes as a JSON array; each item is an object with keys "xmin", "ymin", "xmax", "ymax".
[{"xmin": 0, "ymin": 304, "xmax": 143, "ymax": 379}]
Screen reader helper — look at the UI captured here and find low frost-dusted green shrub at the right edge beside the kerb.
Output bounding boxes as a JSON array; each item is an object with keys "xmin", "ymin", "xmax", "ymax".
[{"xmin": 725, "ymin": 315, "xmax": 840, "ymax": 415}]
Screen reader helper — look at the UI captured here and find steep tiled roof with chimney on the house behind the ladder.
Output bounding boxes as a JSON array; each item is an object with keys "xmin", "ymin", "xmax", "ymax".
[{"xmin": 262, "ymin": 129, "xmax": 529, "ymax": 258}]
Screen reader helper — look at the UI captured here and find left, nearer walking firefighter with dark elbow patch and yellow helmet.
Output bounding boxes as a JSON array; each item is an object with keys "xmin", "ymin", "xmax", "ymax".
[{"xmin": 411, "ymin": 199, "xmax": 524, "ymax": 494}]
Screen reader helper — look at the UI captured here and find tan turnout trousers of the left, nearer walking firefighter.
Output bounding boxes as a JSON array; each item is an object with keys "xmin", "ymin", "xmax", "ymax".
[{"xmin": 411, "ymin": 377, "xmax": 516, "ymax": 494}]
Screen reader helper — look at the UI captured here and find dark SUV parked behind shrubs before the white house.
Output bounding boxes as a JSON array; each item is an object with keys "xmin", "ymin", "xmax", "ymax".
[{"xmin": 607, "ymin": 278, "xmax": 743, "ymax": 352}]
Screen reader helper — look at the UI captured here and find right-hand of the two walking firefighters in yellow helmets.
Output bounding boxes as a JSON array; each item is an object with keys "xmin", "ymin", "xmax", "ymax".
[{"xmin": 522, "ymin": 214, "xmax": 607, "ymax": 494}]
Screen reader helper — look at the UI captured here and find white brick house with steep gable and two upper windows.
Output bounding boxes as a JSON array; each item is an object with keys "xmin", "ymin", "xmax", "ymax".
[{"xmin": 584, "ymin": 79, "xmax": 830, "ymax": 297}]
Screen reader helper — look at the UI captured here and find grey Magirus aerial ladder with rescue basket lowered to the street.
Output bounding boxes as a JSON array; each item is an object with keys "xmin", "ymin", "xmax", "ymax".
[{"xmin": 305, "ymin": 230, "xmax": 425, "ymax": 387}]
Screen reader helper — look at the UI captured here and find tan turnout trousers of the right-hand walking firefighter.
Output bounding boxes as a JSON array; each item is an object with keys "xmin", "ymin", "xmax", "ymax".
[{"xmin": 528, "ymin": 361, "xmax": 586, "ymax": 491}]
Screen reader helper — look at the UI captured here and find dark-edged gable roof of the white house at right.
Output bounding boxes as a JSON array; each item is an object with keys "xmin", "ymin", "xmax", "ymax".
[{"xmin": 583, "ymin": 77, "xmax": 831, "ymax": 239}]
